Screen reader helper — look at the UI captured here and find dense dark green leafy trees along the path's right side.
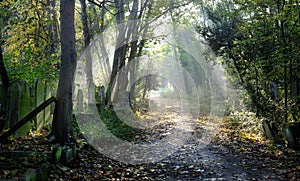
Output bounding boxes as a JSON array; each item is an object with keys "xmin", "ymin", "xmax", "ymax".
[{"xmin": 199, "ymin": 0, "xmax": 300, "ymax": 129}]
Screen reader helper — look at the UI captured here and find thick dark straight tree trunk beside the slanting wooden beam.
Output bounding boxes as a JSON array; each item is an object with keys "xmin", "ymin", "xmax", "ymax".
[{"xmin": 52, "ymin": 0, "xmax": 76, "ymax": 145}]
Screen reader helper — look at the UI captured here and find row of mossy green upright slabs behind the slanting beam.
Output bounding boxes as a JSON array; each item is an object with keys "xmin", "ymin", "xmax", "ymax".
[{"xmin": 0, "ymin": 79, "xmax": 56, "ymax": 138}]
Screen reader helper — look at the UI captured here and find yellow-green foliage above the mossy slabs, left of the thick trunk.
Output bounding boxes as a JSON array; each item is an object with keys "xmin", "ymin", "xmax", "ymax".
[{"xmin": 1, "ymin": 1, "xmax": 59, "ymax": 81}]
